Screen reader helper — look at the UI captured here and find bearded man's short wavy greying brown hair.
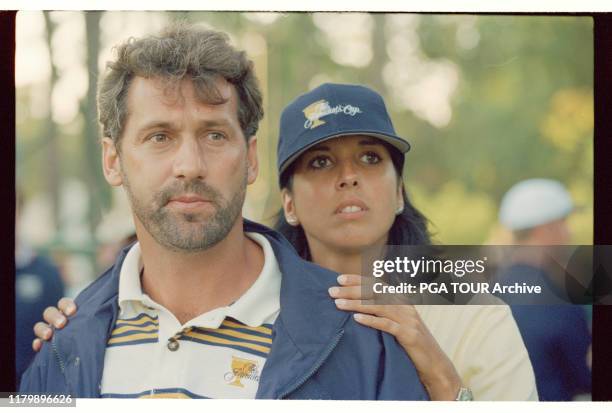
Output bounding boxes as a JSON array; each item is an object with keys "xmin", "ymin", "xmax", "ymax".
[{"xmin": 98, "ymin": 23, "xmax": 263, "ymax": 149}]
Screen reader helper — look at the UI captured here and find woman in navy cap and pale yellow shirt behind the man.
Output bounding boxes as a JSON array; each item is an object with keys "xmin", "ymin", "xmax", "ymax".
[{"xmin": 34, "ymin": 84, "xmax": 537, "ymax": 400}]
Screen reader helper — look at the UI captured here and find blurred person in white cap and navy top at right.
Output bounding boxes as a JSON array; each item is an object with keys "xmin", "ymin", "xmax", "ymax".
[{"xmin": 499, "ymin": 178, "xmax": 591, "ymax": 401}]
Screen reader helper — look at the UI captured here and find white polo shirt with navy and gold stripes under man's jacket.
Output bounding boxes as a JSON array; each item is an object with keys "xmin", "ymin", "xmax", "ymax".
[{"xmin": 101, "ymin": 233, "xmax": 281, "ymax": 399}]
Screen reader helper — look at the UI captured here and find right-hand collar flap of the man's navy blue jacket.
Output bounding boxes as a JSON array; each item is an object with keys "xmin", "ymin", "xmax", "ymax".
[{"xmin": 244, "ymin": 220, "xmax": 349, "ymax": 398}]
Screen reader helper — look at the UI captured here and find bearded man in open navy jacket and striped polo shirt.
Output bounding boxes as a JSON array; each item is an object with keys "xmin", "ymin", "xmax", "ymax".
[{"xmin": 21, "ymin": 25, "xmax": 427, "ymax": 400}]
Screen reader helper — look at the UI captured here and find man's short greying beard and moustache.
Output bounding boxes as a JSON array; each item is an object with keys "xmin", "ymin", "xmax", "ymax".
[{"xmin": 123, "ymin": 169, "xmax": 247, "ymax": 253}]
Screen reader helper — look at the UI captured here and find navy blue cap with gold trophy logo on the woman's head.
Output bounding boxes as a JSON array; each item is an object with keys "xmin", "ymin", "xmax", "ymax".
[{"xmin": 277, "ymin": 83, "xmax": 410, "ymax": 177}]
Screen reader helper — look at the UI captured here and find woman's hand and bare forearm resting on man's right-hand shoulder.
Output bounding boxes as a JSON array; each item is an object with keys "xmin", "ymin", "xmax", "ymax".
[{"xmin": 329, "ymin": 274, "xmax": 462, "ymax": 400}]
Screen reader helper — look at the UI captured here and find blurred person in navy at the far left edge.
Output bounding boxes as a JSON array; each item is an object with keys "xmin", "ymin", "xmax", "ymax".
[{"xmin": 15, "ymin": 190, "xmax": 65, "ymax": 387}]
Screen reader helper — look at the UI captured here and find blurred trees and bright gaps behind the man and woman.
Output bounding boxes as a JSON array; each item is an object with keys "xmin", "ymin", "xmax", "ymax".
[{"xmin": 16, "ymin": 11, "xmax": 593, "ymax": 296}]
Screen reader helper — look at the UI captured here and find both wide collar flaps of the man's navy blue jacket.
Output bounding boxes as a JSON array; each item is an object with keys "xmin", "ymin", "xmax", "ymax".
[{"xmin": 59, "ymin": 219, "xmax": 349, "ymax": 398}]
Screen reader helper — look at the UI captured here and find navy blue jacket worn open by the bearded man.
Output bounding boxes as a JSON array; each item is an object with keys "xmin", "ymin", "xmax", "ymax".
[{"xmin": 20, "ymin": 221, "xmax": 428, "ymax": 400}]
